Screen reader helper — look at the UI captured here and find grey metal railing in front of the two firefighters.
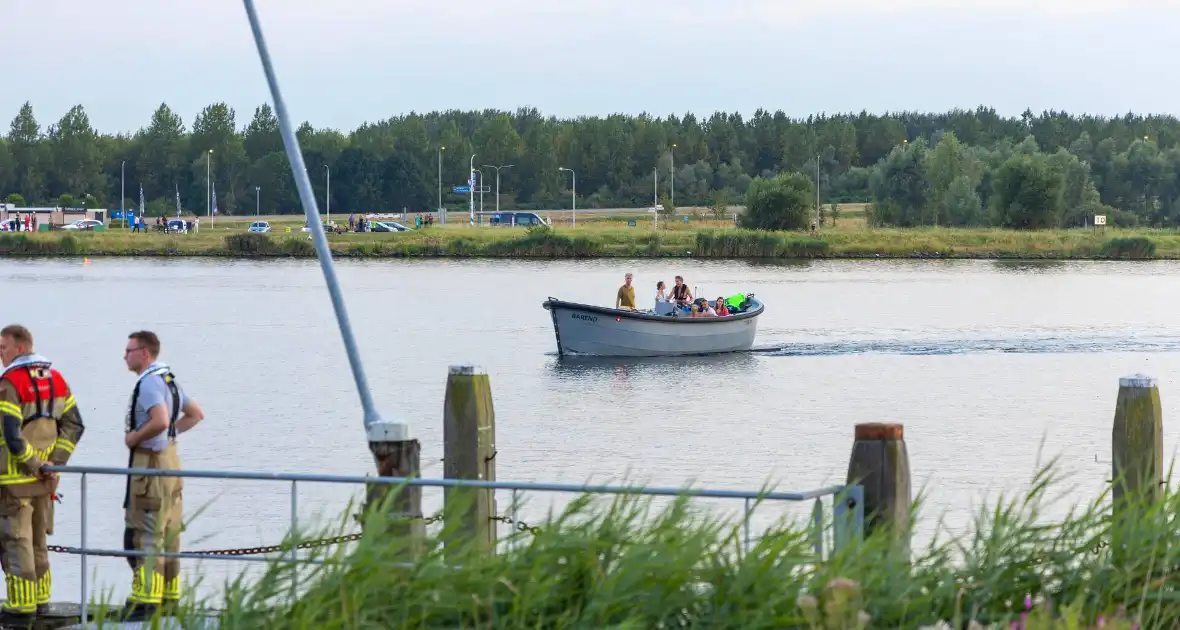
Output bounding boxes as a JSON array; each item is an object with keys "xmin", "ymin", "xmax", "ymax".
[{"xmin": 44, "ymin": 465, "xmax": 865, "ymax": 625}]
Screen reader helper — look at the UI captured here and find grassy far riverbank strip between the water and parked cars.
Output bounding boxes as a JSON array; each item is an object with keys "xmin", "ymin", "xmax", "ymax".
[{"xmin": 0, "ymin": 221, "xmax": 1180, "ymax": 260}]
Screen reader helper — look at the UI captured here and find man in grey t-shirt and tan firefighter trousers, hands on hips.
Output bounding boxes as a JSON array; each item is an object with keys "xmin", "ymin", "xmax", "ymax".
[{"xmin": 123, "ymin": 330, "xmax": 204, "ymax": 621}]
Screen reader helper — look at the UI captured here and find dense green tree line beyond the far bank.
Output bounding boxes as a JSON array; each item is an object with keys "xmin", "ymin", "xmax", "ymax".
[{"xmin": 0, "ymin": 103, "xmax": 1180, "ymax": 228}]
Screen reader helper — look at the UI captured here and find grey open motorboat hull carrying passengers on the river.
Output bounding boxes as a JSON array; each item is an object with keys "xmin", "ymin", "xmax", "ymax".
[{"xmin": 542, "ymin": 294, "xmax": 763, "ymax": 356}]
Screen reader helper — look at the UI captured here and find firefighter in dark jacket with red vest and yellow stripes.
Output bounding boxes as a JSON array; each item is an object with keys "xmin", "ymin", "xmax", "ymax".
[{"xmin": 0, "ymin": 324, "xmax": 86, "ymax": 626}]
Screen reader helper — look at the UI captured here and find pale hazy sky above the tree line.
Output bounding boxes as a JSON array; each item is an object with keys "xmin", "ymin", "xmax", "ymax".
[{"xmin": 0, "ymin": 0, "xmax": 1180, "ymax": 133}]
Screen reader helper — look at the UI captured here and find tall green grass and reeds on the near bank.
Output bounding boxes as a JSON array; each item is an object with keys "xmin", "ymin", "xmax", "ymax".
[{"xmin": 154, "ymin": 467, "xmax": 1161, "ymax": 630}]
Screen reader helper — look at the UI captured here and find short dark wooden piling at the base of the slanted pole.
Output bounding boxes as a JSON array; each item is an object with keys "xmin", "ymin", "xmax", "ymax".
[{"xmin": 365, "ymin": 420, "xmax": 426, "ymax": 557}]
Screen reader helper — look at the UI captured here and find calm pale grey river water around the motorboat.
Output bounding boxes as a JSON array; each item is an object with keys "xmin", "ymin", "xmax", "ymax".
[{"xmin": 0, "ymin": 258, "xmax": 1180, "ymax": 601}]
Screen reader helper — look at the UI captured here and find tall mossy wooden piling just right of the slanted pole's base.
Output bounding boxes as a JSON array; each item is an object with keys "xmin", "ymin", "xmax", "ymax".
[{"xmin": 443, "ymin": 366, "xmax": 497, "ymax": 553}]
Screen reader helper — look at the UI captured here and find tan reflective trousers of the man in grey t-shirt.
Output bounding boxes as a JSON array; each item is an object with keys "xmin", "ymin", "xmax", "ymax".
[{"xmin": 123, "ymin": 442, "xmax": 183, "ymax": 604}]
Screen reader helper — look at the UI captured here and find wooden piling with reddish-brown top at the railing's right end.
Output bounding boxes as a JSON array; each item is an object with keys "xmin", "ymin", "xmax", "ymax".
[{"xmin": 847, "ymin": 422, "xmax": 913, "ymax": 553}]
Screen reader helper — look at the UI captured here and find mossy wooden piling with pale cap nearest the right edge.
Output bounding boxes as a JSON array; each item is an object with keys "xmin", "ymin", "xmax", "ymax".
[{"xmin": 1110, "ymin": 374, "xmax": 1163, "ymax": 514}]
